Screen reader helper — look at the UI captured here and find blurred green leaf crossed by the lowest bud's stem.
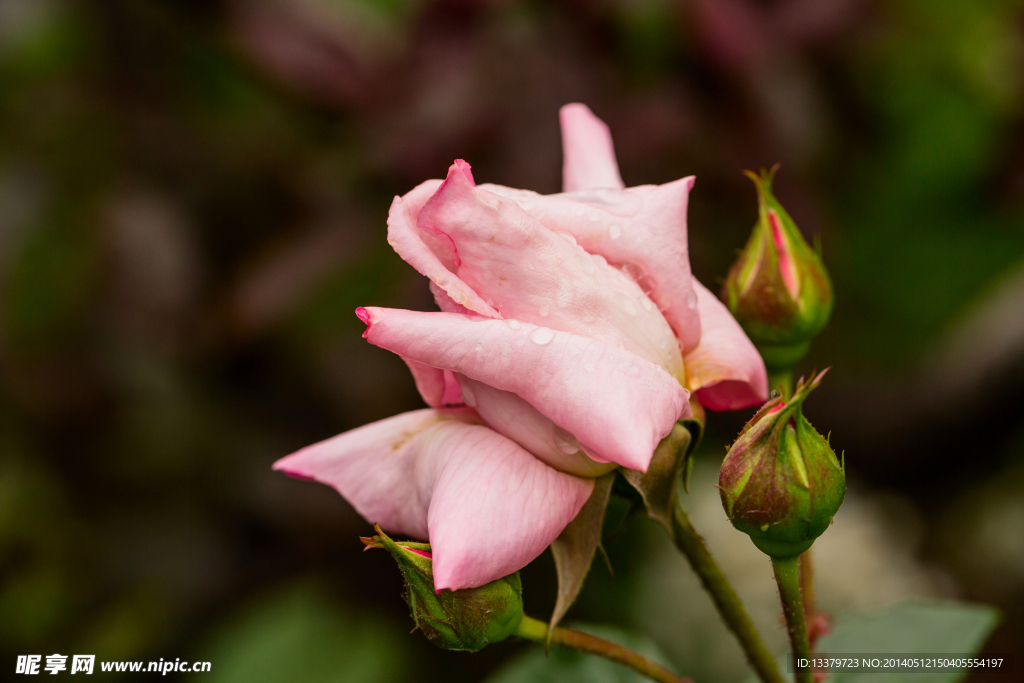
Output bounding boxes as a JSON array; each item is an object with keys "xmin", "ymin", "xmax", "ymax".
[{"xmin": 485, "ymin": 624, "xmax": 673, "ymax": 683}]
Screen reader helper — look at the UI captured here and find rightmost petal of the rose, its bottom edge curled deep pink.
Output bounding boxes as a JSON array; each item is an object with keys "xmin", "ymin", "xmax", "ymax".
[{"xmin": 684, "ymin": 279, "xmax": 768, "ymax": 411}]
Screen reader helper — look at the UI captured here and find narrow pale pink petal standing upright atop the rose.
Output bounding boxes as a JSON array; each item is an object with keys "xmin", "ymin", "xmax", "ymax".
[{"xmin": 558, "ymin": 103, "xmax": 625, "ymax": 193}]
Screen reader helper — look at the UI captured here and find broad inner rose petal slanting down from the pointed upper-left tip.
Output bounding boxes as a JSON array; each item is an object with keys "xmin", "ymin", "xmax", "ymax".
[{"xmin": 419, "ymin": 166, "xmax": 683, "ymax": 379}]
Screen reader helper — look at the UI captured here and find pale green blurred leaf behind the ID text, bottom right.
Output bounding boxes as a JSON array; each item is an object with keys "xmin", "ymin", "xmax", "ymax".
[{"xmin": 817, "ymin": 601, "xmax": 999, "ymax": 683}]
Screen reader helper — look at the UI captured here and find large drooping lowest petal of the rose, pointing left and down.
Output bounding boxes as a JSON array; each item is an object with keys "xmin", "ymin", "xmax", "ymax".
[{"xmin": 273, "ymin": 409, "xmax": 594, "ymax": 591}]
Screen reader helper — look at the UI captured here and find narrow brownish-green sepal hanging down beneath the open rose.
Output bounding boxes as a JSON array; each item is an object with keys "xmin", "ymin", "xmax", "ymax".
[{"xmin": 549, "ymin": 472, "xmax": 615, "ymax": 633}]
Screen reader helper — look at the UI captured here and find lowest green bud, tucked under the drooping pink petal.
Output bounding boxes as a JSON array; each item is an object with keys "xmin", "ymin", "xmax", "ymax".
[{"xmin": 362, "ymin": 526, "xmax": 522, "ymax": 652}]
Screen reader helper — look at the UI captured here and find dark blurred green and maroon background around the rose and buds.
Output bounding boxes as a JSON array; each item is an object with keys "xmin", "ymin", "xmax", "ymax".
[{"xmin": 0, "ymin": 0, "xmax": 1024, "ymax": 683}]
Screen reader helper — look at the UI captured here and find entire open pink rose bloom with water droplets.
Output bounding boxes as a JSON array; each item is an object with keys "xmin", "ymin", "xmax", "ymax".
[{"xmin": 274, "ymin": 104, "xmax": 768, "ymax": 591}]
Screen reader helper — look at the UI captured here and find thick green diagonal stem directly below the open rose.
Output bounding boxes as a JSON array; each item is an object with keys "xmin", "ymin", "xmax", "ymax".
[{"xmin": 672, "ymin": 499, "xmax": 785, "ymax": 683}]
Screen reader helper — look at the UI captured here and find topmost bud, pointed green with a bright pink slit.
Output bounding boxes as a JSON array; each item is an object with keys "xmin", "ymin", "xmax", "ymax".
[{"xmin": 722, "ymin": 166, "xmax": 833, "ymax": 372}]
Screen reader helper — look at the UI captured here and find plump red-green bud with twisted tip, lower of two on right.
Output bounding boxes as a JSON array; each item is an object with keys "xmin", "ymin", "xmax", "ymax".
[{"xmin": 719, "ymin": 372, "xmax": 846, "ymax": 559}]
